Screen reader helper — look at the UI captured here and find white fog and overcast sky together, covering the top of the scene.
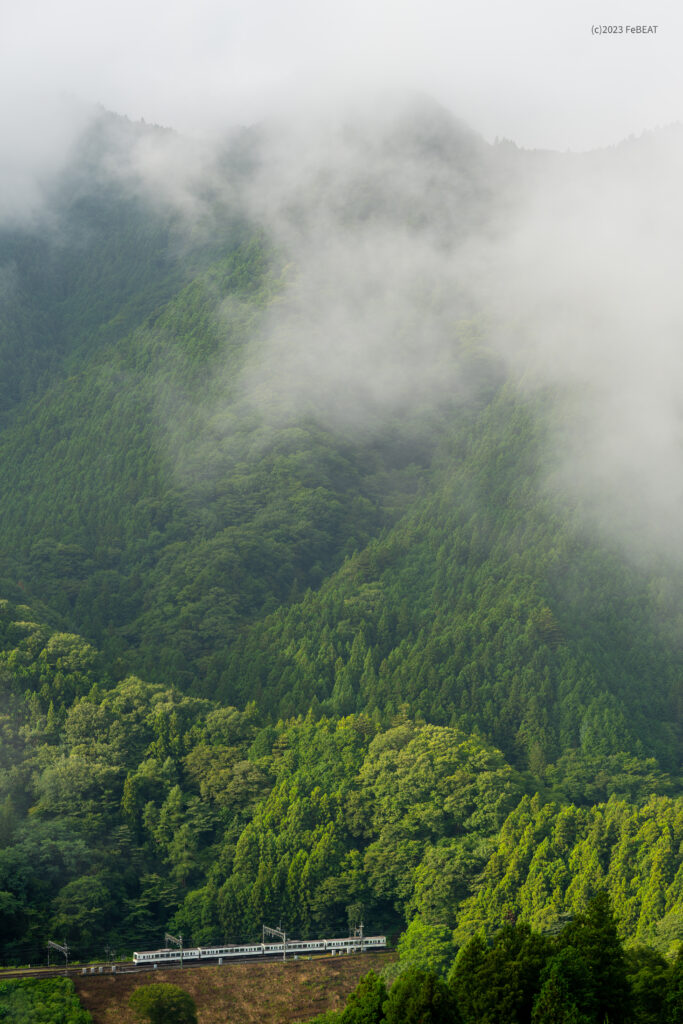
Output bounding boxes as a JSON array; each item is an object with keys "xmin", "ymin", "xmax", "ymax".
[{"xmin": 0, "ymin": 0, "xmax": 683, "ymax": 550}]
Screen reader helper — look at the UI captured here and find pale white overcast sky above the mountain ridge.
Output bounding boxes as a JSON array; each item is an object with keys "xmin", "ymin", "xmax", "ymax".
[{"xmin": 0, "ymin": 0, "xmax": 683, "ymax": 150}]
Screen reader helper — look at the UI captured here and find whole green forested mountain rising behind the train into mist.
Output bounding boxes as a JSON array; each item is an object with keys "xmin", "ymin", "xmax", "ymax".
[{"xmin": 0, "ymin": 103, "xmax": 683, "ymax": 974}]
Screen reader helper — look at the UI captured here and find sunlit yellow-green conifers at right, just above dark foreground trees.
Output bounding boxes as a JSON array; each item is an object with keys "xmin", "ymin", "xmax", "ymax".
[{"xmin": 456, "ymin": 796, "xmax": 683, "ymax": 952}]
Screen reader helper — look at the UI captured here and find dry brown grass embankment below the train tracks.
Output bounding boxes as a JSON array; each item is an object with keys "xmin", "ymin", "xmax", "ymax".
[{"xmin": 74, "ymin": 953, "xmax": 390, "ymax": 1024}]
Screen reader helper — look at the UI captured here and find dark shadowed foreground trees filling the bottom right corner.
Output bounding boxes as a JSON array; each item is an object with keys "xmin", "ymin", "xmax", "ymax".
[{"xmin": 314, "ymin": 892, "xmax": 683, "ymax": 1024}]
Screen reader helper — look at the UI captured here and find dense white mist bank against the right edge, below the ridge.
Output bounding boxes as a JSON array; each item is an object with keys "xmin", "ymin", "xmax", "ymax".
[{"xmin": 466, "ymin": 128, "xmax": 683, "ymax": 559}]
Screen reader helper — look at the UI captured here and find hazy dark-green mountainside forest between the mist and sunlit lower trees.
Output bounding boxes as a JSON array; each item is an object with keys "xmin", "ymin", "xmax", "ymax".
[{"xmin": 0, "ymin": 161, "xmax": 680, "ymax": 770}]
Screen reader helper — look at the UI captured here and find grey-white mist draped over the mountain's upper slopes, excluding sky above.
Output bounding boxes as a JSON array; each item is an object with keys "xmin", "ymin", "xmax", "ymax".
[{"xmin": 0, "ymin": 84, "xmax": 683, "ymax": 569}]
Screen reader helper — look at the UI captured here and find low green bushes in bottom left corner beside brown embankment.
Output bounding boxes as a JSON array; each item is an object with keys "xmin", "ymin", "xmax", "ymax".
[{"xmin": 0, "ymin": 978, "xmax": 92, "ymax": 1024}]
